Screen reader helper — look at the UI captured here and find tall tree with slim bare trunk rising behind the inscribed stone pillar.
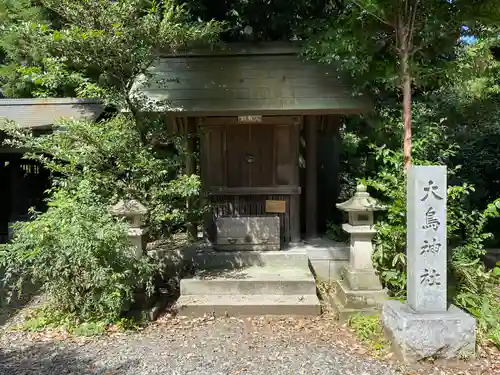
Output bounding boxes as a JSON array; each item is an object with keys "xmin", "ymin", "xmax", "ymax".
[{"xmin": 309, "ymin": 0, "xmax": 500, "ymax": 168}]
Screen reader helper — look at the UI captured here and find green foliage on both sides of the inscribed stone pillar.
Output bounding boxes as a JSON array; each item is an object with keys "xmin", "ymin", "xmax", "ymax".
[{"xmin": 364, "ymin": 143, "xmax": 500, "ymax": 345}]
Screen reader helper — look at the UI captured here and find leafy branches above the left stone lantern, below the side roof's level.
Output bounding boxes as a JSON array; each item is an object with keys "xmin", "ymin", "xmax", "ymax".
[{"xmin": 0, "ymin": 115, "xmax": 203, "ymax": 241}]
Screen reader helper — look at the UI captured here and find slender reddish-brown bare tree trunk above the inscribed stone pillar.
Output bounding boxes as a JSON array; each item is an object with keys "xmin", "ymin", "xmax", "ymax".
[{"xmin": 401, "ymin": 48, "xmax": 411, "ymax": 170}]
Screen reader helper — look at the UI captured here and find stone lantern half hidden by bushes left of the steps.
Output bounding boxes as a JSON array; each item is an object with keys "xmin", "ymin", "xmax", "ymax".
[{"xmin": 111, "ymin": 199, "xmax": 149, "ymax": 257}]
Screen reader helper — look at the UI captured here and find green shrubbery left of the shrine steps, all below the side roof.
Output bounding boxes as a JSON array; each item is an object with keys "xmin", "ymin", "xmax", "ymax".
[{"xmin": 0, "ymin": 104, "xmax": 203, "ymax": 325}]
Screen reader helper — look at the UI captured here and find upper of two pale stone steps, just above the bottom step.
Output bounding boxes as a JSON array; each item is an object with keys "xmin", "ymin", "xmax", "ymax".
[{"xmin": 180, "ymin": 265, "xmax": 316, "ymax": 296}]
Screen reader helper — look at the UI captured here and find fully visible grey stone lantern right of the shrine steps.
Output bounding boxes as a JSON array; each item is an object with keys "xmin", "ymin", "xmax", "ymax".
[{"xmin": 333, "ymin": 184, "xmax": 387, "ymax": 319}]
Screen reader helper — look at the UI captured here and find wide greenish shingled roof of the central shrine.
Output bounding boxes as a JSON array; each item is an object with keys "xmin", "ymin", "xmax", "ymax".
[{"xmin": 132, "ymin": 43, "xmax": 371, "ymax": 116}]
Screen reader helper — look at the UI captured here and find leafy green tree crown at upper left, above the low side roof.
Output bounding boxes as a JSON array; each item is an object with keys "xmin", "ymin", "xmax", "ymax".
[{"xmin": 0, "ymin": 0, "xmax": 220, "ymax": 106}]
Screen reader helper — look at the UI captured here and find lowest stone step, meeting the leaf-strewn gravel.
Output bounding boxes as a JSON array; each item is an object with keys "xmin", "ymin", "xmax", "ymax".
[{"xmin": 176, "ymin": 294, "xmax": 321, "ymax": 317}]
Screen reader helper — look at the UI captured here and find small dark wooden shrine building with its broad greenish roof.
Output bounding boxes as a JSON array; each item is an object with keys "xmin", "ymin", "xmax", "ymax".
[{"xmin": 133, "ymin": 43, "xmax": 370, "ymax": 248}]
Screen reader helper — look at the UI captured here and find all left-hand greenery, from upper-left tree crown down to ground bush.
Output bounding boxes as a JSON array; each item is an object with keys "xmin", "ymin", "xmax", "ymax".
[{"xmin": 0, "ymin": 0, "xmax": 220, "ymax": 322}]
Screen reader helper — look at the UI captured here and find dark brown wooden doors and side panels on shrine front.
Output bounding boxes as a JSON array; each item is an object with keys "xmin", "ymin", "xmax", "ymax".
[{"xmin": 201, "ymin": 117, "xmax": 299, "ymax": 192}]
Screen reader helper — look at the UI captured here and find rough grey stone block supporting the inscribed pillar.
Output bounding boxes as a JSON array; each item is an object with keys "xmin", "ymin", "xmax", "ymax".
[{"xmin": 382, "ymin": 301, "xmax": 476, "ymax": 362}]
